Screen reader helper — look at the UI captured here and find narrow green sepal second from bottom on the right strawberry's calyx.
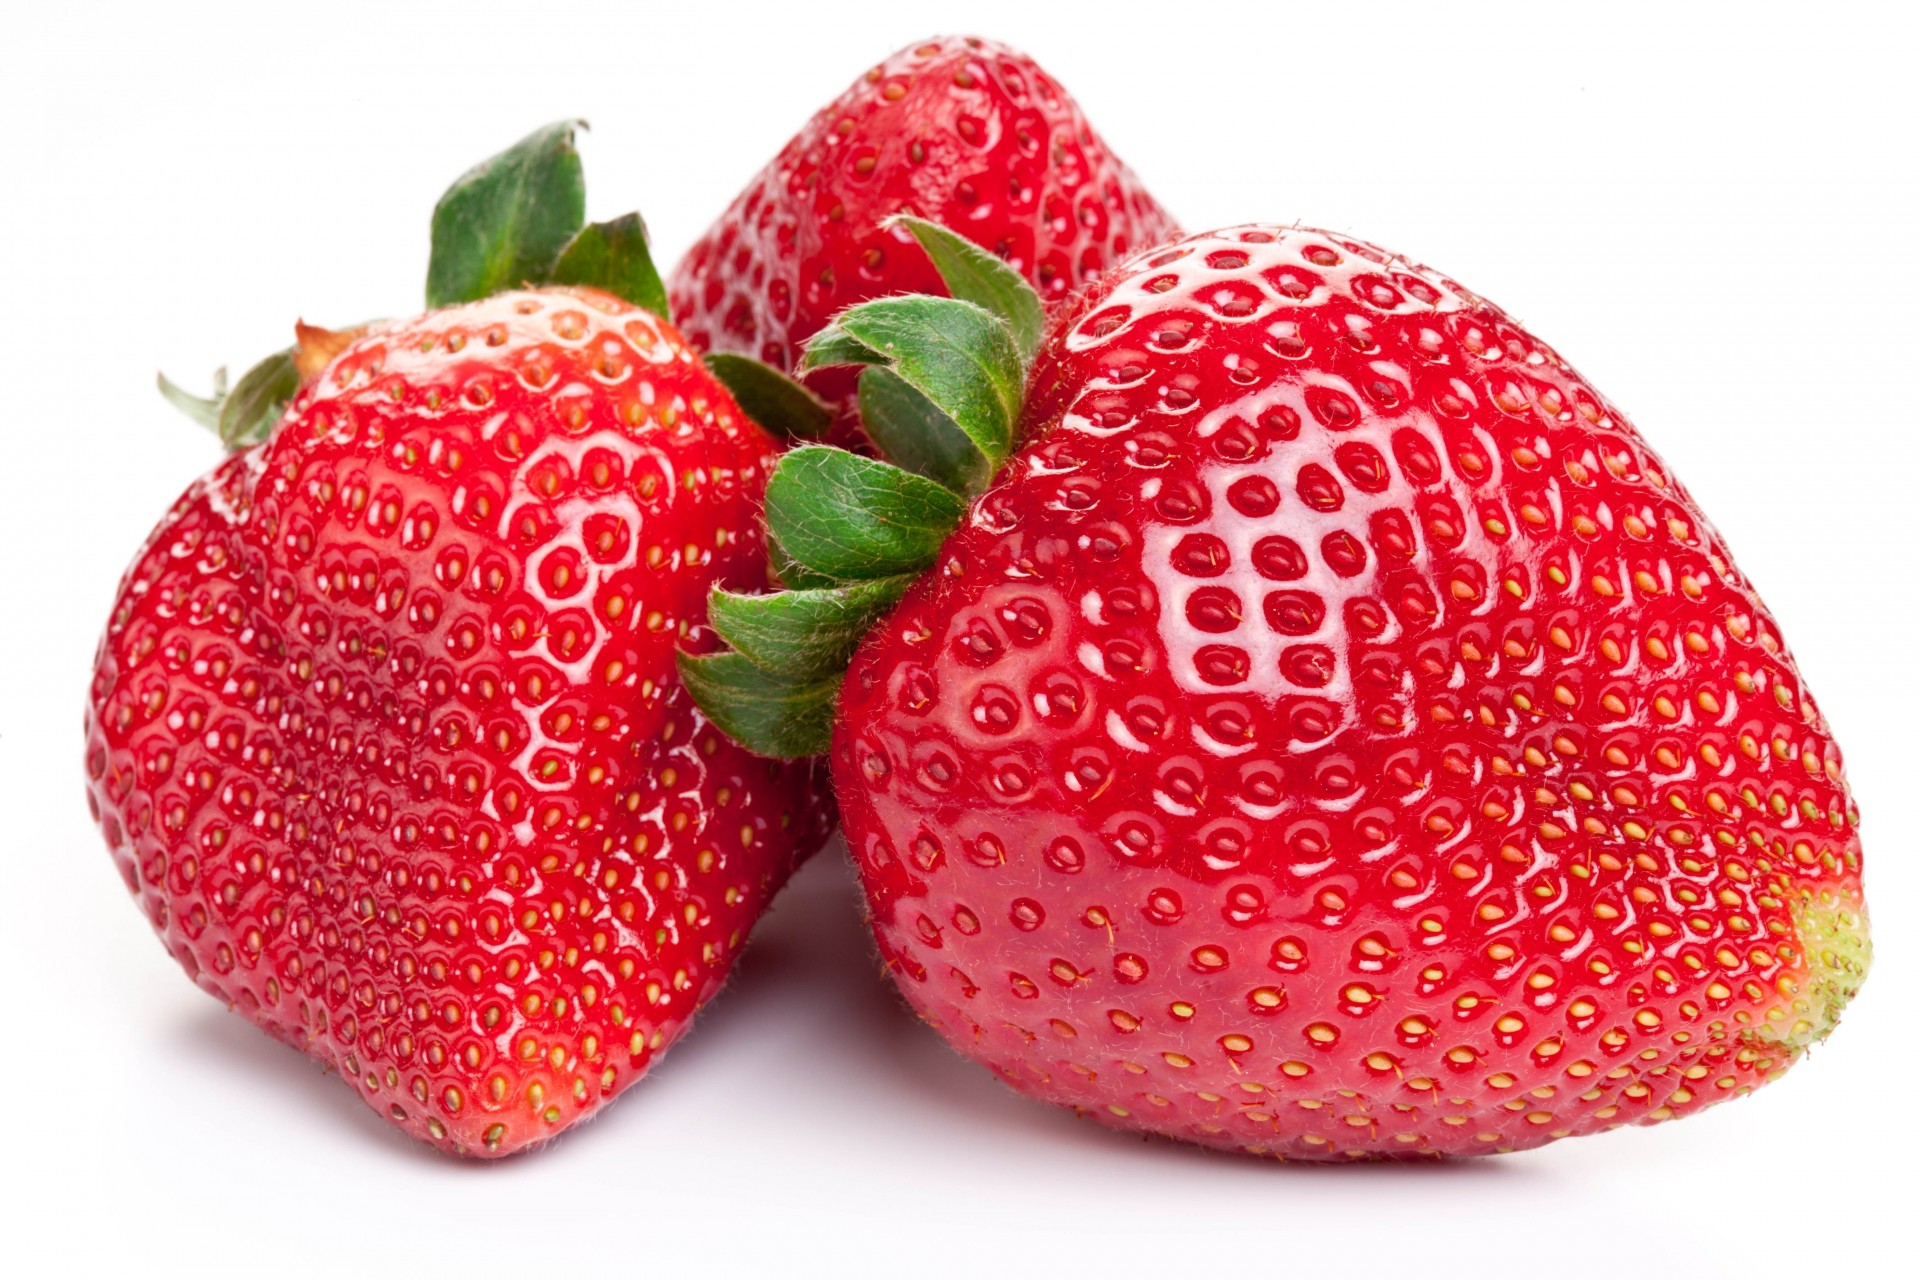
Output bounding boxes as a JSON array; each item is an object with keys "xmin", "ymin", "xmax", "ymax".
[{"xmin": 707, "ymin": 574, "xmax": 914, "ymax": 681}]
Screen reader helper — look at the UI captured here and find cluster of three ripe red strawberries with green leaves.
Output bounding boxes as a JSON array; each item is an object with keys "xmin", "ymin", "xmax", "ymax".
[{"xmin": 88, "ymin": 38, "xmax": 1866, "ymax": 1157}]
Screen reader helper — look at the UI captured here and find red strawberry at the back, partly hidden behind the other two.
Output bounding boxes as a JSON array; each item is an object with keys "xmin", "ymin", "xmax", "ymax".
[{"xmin": 668, "ymin": 36, "xmax": 1175, "ymax": 439}]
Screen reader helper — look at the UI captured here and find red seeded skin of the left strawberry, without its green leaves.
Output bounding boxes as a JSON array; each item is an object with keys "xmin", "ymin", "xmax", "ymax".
[{"xmin": 86, "ymin": 290, "xmax": 829, "ymax": 1155}]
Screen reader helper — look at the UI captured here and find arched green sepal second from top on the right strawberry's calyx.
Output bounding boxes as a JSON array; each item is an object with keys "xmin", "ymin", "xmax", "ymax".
[{"xmin": 803, "ymin": 294, "xmax": 1025, "ymax": 466}]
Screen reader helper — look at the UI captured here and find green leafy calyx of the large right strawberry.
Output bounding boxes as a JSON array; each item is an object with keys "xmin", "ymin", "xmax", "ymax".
[{"xmin": 680, "ymin": 215, "xmax": 1044, "ymax": 758}]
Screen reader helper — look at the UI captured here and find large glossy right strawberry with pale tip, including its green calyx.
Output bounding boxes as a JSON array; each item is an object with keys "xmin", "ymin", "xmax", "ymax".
[{"xmin": 682, "ymin": 226, "xmax": 1868, "ymax": 1159}]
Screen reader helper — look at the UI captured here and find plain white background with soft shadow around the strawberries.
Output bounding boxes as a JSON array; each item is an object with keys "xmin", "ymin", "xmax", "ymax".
[{"xmin": 0, "ymin": 0, "xmax": 1920, "ymax": 1278}]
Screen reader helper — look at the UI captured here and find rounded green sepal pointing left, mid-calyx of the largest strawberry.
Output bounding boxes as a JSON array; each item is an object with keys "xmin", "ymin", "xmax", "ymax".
[{"xmin": 766, "ymin": 445, "xmax": 964, "ymax": 581}]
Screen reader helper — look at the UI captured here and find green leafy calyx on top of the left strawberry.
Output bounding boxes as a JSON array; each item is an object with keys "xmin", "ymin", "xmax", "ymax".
[{"xmin": 159, "ymin": 121, "xmax": 683, "ymax": 453}]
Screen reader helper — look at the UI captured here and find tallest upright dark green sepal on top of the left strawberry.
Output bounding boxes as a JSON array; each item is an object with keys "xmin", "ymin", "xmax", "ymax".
[{"xmin": 426, "ymin": 121, "xmax": 588, "ymax": 307}]
